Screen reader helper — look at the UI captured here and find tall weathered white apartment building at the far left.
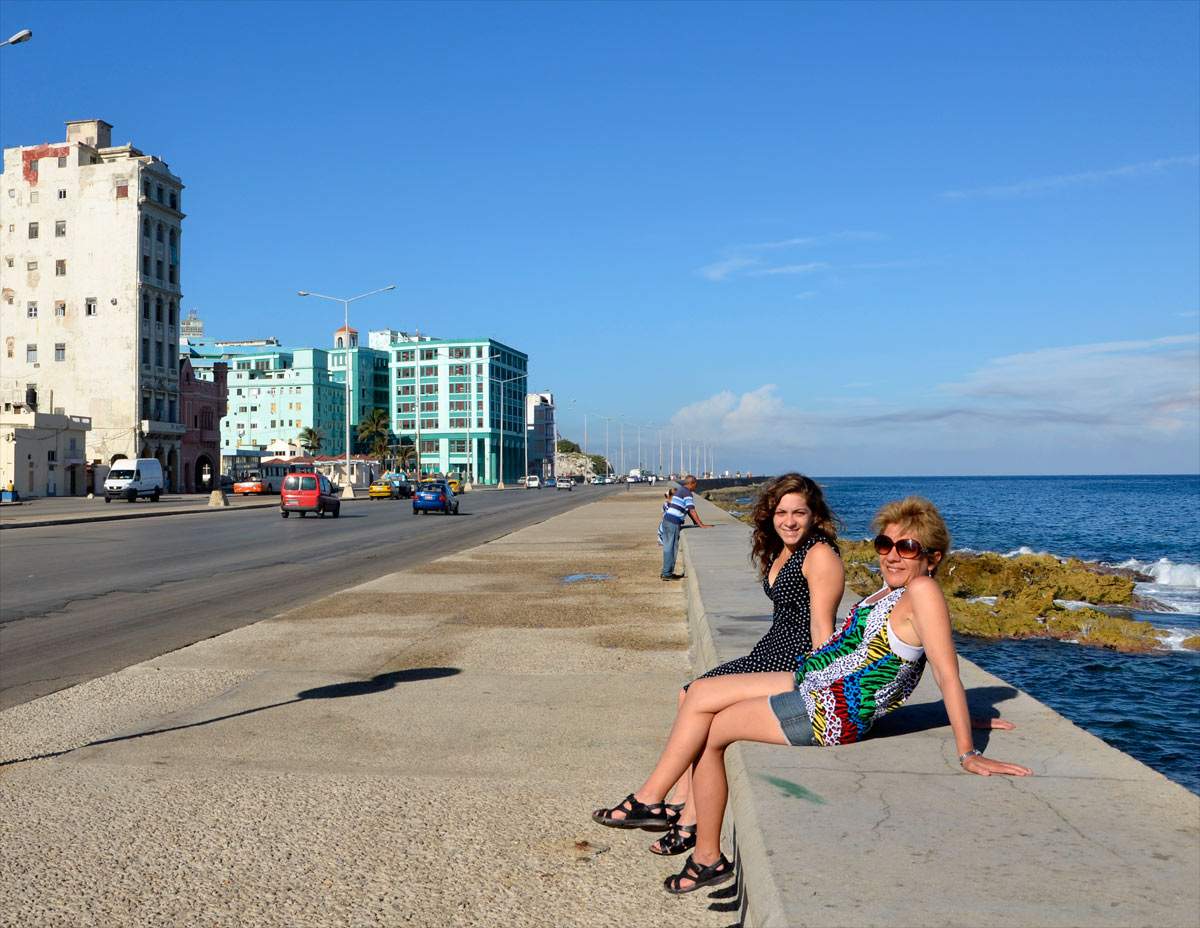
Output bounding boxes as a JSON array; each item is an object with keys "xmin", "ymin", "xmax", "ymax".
[{"xmin": 0, "ymin": 119, "xmax": 185, "ymax": 487}]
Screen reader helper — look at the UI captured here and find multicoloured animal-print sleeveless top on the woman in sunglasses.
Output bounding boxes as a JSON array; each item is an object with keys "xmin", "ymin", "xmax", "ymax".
[{"xmin": 797, "ymin": 587, "xmax": 925, "ymax": 747}]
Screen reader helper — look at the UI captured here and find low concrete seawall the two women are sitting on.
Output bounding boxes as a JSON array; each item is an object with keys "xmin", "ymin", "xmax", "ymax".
[{"xmin": 683, "ymin": 499, "xmax": 1200, "ymax": 928}]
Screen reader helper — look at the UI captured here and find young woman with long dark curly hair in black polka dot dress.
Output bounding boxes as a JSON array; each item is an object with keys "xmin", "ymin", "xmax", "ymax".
[{"xmin": 592, "ymin": 473, "xmax": 845, "ymax": 855}]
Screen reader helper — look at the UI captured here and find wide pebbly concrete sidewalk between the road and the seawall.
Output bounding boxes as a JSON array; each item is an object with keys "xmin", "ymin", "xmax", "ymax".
[{"xmin": 0, "ymin": 491, "xmax": 736, "ymax": 928}]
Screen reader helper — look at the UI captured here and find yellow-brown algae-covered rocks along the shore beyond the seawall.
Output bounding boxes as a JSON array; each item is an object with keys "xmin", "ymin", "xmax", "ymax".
[{"xmin": 704, "ymin": 485, "xmax": 1200, "ymax": 653}]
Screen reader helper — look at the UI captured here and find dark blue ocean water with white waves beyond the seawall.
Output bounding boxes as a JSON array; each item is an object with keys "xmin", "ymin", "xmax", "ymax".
[{"xmin": 820, "ymin": 475, "xmax": 1200, "ymax": 794}]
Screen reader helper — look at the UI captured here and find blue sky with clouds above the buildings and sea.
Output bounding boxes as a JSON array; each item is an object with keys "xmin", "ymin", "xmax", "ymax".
[{"xmin": 0, "ymin": 0, "xmax": 1200, "ymax": 475}]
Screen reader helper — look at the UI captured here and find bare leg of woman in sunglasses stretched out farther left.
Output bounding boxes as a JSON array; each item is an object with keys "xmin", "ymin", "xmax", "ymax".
[{"xmin": 634, "ymin": 671, "xmax": 796, "ymax": 804}]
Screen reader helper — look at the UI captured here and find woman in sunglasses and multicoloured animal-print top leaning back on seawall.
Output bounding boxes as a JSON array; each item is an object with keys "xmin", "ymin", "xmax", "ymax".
[{"xmin": 590, "ymin": 497, "xmax": 1032, "ymax": 893}]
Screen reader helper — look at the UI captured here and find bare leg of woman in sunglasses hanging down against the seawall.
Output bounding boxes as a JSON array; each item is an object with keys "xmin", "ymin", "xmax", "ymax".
[{"xmin": 684, "ymin": 696, "xmax": 790, "ymax": 885}]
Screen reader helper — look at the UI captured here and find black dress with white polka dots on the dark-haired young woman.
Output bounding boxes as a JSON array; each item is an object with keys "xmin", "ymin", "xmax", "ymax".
[{"xmin": 701, "ymin": 533, "xmax": 840, "ymax": 679}]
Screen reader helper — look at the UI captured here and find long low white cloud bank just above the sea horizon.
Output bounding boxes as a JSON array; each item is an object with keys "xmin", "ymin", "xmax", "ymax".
[{"xmin": 671, "ymin": 335, "xmax": 1200, "ymax": 474}]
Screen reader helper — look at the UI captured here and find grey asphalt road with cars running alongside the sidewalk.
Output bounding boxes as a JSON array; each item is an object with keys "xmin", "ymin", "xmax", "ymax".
[{"xmin": 0, "ymin": 487, "xmax": 618, "ymax": 708}]
